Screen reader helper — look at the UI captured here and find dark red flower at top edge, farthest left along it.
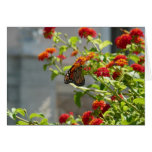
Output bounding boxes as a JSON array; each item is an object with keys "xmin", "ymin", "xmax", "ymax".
[{"xmin": 43, "ymin": 27, "xmax": 56, "ymax": 39}]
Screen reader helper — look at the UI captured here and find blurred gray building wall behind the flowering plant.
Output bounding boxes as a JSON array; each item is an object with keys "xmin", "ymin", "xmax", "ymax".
[{"xmin": 7, "ymin": 27, "xmax": 144, "ymax": 125}]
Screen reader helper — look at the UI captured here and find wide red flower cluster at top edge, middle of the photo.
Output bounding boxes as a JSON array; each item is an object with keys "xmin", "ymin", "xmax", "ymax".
[{"xmin": 78, "ymin": 27, "xmax": 97, "ymax": 38}]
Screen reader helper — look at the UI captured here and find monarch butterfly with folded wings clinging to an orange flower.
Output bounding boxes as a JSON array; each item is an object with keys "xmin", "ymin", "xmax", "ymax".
[{"xmin": 64, "ymin": 65, "xmax": 85, "ymax": 86}]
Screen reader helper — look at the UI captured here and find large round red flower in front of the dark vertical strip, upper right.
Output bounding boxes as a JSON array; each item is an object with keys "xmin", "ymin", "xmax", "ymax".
[{"xmin": 115, "ymin": 34, "xmax": 131, "ymax": 49}]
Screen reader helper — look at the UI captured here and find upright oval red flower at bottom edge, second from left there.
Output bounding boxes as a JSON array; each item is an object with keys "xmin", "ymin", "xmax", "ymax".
[{"xmin": 82, "ymin": 111, "xmax": 94, "ymax": 125}]
